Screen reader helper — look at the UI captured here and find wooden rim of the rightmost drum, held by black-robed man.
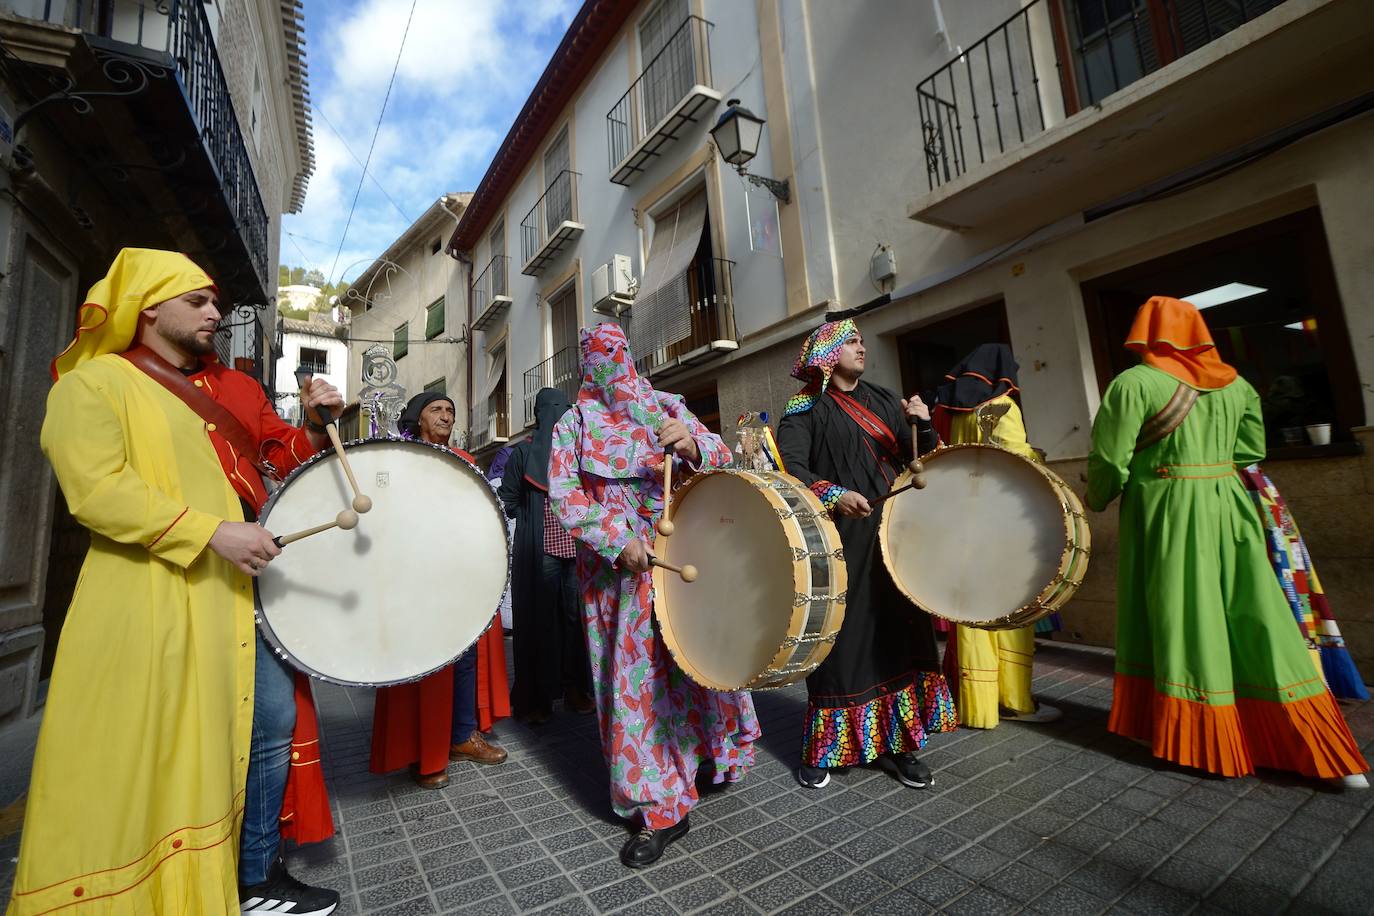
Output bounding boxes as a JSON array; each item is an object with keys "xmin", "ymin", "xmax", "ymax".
[{"xmin": 878, "ymin": 442, "xmax": 1092, "ymax": 630}]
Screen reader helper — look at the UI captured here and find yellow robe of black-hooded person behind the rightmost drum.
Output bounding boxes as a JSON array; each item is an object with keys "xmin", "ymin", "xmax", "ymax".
[{"xmin": 949, "ymin": 396, "xmax": 1039, "ymax": 728}]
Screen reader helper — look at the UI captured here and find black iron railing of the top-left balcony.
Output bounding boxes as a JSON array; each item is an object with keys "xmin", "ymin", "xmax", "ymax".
[{"xmin": 17, "ymin": 0, "xmax": 275, "ymax": 290}]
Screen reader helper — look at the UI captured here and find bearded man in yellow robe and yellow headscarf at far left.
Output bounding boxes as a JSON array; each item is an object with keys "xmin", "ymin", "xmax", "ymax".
[{"xmin": 8, "ymin": 249, "xmax": 342, "ymax": 915}]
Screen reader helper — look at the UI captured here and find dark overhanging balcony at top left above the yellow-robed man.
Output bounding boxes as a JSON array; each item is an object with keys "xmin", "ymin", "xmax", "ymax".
[{"xmin": 0, "ymin": 0, "xmax": 276, "ymax": 304}]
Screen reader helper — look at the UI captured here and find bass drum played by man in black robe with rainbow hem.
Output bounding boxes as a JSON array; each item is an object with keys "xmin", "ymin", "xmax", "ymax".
[{"xmin": 878, "ymin": 444, "xmax": 1091, "ymax": 630}]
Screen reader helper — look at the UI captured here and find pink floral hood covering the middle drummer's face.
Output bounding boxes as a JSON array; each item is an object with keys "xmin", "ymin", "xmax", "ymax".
[{"xmin": 577, "ymin": 324, "xmax": 676, "ymax": 478}]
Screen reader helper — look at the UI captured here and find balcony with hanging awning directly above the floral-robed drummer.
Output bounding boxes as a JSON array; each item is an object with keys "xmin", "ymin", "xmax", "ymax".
[{"xmin": 628, "ymin": 258, "xmax": 739, "ymax": 378}]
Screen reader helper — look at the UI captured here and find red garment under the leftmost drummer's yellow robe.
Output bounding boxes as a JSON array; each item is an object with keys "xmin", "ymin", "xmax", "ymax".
[{"xmin": 190, "ymin": 360, "xmax": 334, "ymax": 843}]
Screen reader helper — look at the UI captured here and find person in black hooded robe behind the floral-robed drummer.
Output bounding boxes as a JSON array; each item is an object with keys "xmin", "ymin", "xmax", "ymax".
[{"xmin": 500, "ymin": 389, "xmax": 595, "ymax": 724}]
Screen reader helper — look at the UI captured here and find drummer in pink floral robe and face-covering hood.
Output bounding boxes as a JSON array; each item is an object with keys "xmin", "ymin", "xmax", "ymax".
[{"xmin": 548, "ymin": 324, "xmax": 758, "ymax": 868}]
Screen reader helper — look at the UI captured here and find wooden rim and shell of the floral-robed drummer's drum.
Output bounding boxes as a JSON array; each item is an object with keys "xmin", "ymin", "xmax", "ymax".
[{"xmin": 653, "ymin": 467, "xmax": 849, "ymax": 692}]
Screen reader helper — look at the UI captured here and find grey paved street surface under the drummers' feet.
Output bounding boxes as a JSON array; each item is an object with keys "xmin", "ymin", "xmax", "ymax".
[{"xmin": 0, "ymin": 643, "xmax": 1374, "ymax": 916}]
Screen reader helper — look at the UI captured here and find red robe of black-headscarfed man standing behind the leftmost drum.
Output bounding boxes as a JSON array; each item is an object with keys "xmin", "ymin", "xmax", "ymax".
[{"xmin": 368, "ymin": 449, "xmax": 511, "ymax": 775}]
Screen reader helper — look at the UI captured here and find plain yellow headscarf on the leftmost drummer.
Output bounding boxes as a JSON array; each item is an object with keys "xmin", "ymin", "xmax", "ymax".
[{"xmin": 49, "ymin": 249, "xmax": 220, "ymax": 379}]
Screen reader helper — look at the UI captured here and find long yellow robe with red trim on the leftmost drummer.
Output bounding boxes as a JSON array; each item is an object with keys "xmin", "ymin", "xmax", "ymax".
[{"xmin": 10, "ymin": 356, "xmax": 256, "ymax": 915}]
